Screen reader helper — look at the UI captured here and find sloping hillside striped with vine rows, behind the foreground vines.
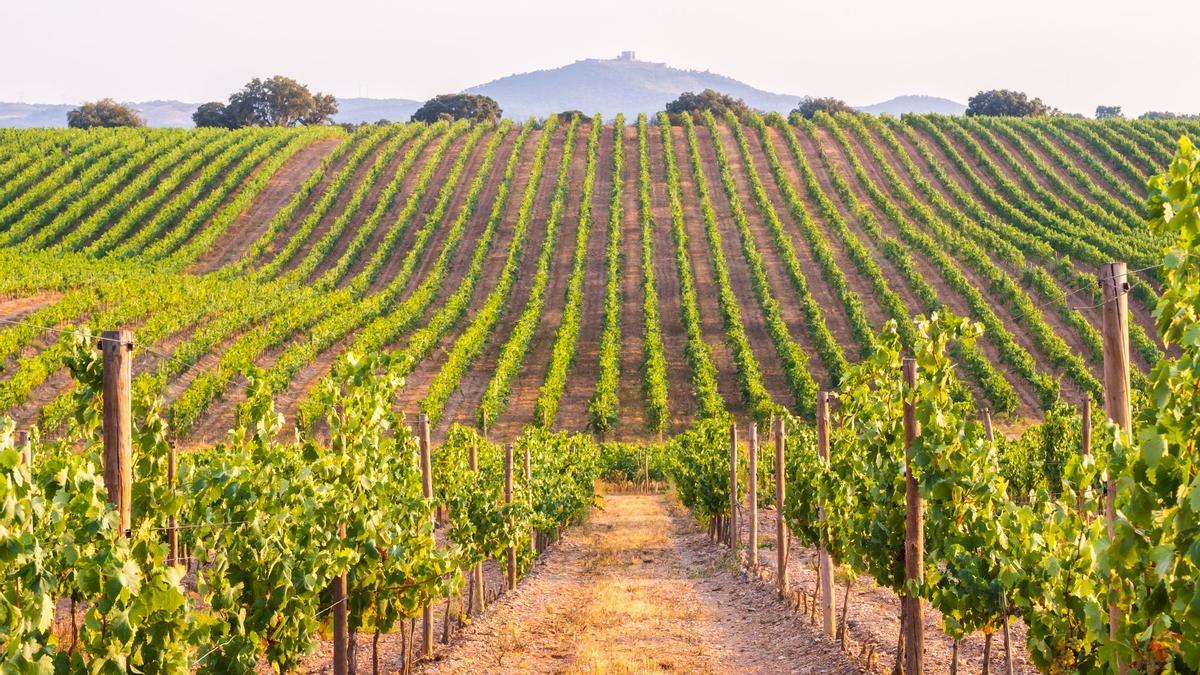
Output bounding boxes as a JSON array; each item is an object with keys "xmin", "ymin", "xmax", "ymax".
[{"xmin": 0, "ymin": 115, "xmax": 1180, "ymax": 444}]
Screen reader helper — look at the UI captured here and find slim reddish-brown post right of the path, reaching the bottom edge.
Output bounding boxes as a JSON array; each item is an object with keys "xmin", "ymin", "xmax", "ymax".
[{"xmin": 901, "ymin": 358, "xmax": 925, "ymax": 675}]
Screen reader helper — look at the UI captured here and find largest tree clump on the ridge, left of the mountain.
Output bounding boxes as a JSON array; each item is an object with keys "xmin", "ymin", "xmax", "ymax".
[{"xmin": 192, "ymin": 74, "xmax": 337, "ymax": 129}]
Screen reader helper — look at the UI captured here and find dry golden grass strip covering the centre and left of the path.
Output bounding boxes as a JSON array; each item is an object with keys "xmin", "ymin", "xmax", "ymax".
[{"xmin": 432, "ymin": 494, "xmax": 725, "ymax": 674}]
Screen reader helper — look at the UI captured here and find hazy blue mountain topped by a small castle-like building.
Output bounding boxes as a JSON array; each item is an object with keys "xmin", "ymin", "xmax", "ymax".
[{"xmin": 466, "ymin": 52, "xmax": 799, "ymax": 119}]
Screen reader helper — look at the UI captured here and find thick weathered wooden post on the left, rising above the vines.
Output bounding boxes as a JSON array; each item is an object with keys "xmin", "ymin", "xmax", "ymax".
[{"xmin": 100, "ymin": 330, "xmax": 133, "ymax": 537}]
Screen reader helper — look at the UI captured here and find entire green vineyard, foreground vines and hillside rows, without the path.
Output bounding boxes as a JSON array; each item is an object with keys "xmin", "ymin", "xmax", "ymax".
[{"xmin": 0, "ymin": 113, "xmax": 1200, "ymax": 673}]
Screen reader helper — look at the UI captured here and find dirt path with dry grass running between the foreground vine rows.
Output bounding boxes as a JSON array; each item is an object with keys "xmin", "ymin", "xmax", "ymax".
[{"xmin": 426, "ymin": 487, "xmax": 857, "ymax": 673}]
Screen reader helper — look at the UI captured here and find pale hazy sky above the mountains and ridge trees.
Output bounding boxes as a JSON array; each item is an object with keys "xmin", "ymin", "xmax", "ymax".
[{"xmin": 0, "ymin": 0, "xmax": 1200, "ymax": 114}]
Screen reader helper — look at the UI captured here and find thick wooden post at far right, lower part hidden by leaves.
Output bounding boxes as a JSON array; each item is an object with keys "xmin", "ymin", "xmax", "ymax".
[{"xmin": 1100, "ymin": 258, "xmax": 1133, "ymax": 673}]
